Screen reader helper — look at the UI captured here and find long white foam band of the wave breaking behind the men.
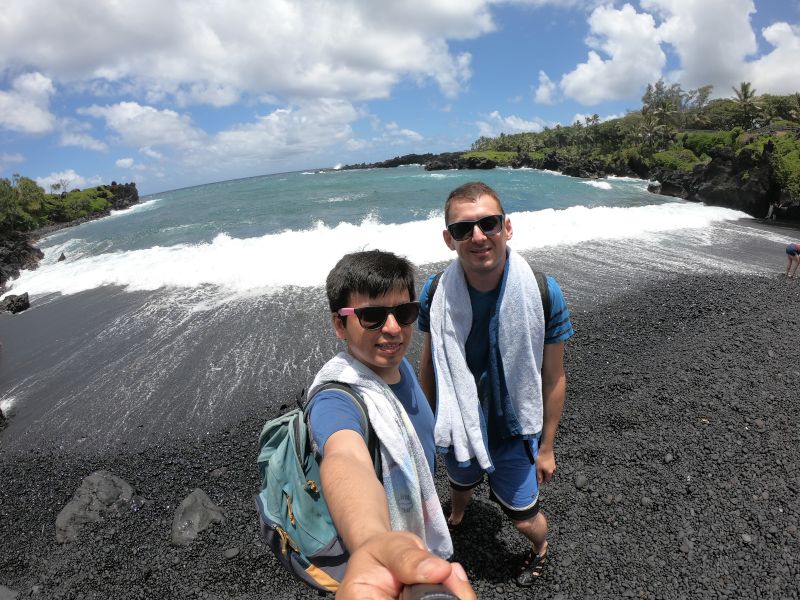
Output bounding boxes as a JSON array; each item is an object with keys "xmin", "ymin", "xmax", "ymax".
[{"xmin": 3, "ymin": 202, "xmax": 747, "ymax": 296}]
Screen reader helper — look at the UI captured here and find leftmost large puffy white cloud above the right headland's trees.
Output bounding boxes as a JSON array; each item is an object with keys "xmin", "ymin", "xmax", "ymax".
[{"xmin": 560, "ymin": 0, "xmax": 668, "ymax": 105}]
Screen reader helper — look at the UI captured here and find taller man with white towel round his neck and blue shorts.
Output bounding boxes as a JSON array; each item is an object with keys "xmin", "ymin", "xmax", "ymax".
[{"xmin": 419, "ymin": 182, "xmax": 573, "ymax": 587}]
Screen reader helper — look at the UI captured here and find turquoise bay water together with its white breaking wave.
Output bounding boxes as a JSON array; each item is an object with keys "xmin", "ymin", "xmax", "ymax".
[{"xmin": 6, "ymin": 166, "xmax": 744, "ymax": 295}]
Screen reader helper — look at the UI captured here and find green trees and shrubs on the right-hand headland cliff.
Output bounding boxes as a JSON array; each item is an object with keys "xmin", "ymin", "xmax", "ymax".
[{"xmin": 464, "ymin": 80, "xmax": 800, "ymax": 202}]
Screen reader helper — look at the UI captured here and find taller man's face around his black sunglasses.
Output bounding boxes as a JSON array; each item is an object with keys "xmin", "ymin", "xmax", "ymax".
[{"xmin": 443, "ymin": 195, "xmax": 513, "ymax": 283}]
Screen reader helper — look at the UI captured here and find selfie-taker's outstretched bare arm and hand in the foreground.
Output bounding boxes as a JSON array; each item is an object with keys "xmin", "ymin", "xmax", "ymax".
[{"xmin": 320, "ymin": 429, "xmax": 476, "ymax": 600}]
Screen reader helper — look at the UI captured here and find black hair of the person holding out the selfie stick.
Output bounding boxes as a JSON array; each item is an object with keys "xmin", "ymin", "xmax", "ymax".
[{"xmin": 325, "ymin": 250, "xmax": 416, "ymax": 312}]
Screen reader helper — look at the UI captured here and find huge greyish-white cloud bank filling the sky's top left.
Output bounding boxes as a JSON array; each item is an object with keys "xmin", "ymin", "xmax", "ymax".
[{"xmin": 0, "ymin": 0, "xmax": 494, "ymax": 106}]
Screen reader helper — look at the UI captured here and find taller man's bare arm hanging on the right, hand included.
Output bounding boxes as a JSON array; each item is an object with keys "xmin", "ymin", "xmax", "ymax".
[{"xmin": 536, "ymin": 342, "xmax": 567, "ymax": 483}]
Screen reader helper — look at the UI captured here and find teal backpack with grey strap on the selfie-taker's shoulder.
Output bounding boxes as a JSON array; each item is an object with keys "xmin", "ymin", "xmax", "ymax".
[{"xmin": 256, "ymin": 383, "xmax": 381, "ymax": 593}]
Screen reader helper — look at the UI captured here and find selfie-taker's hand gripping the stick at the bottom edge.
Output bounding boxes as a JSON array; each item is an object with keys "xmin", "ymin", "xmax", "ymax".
[{"xmin": 336, "ymin": 531, "xmax": 477, "ymax": 600}]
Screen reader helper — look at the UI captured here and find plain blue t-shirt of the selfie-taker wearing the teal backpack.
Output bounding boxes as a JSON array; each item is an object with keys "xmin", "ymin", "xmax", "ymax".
[{"xmin": 308, "ymin": 358, "xmax": 436, "ymax": 473}]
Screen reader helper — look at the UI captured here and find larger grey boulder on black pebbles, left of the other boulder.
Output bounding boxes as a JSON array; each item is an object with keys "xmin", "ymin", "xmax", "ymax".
[{"xmin": 56, "ymin": 471, "xmax": 133, "ymax": 544}]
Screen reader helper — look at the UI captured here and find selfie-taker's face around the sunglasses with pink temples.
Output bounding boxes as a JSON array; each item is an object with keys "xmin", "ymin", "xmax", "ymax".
[{"xmin": 332, "ymin": 288, "xmax": 414, "ymax": 383}]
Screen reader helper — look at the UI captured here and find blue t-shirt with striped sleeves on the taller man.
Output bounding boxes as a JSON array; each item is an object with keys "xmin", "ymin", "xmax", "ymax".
[{"xmin": 417, "ymin": 268, "xmax": 574, "ymax": 445}]
